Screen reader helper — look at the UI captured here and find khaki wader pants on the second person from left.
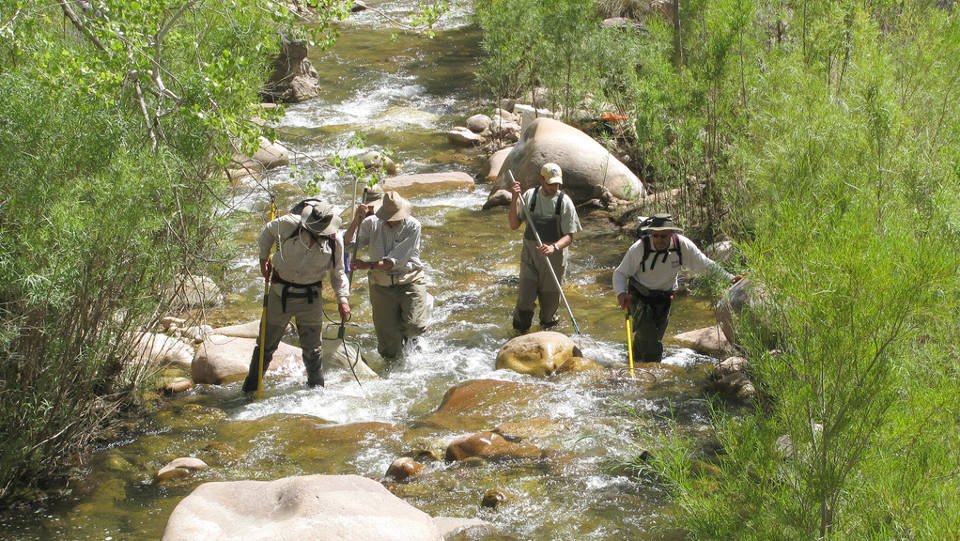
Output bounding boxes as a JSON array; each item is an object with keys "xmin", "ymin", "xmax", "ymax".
[{"xmin": 370, "ymin": 280, "xmax": 428, "ymax": 359}]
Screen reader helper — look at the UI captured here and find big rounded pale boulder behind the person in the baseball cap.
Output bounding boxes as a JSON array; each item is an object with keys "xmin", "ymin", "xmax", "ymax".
[{"xmin": 490, "ymin": 118, "xmax": 646, "ymax": 203}]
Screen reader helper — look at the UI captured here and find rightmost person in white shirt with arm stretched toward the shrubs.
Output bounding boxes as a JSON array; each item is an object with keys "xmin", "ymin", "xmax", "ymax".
[{"xmin": 613, "ymin": 214, "xmax": 739, "ymax": 362}]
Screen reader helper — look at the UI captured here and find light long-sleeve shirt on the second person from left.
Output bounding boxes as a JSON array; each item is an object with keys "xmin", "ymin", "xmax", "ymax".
[{"xmin": 346, "ymin": 216, "xmax": 423, "ymax": 276}]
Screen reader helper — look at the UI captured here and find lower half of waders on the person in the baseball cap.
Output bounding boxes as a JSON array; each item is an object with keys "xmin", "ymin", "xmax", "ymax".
[{"xmin": 513, "ymin": 239, "xmax": 567, "ymax": 332}]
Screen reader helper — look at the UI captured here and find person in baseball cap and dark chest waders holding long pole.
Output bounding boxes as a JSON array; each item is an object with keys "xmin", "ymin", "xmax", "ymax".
[{"xmin": 508, "ymin": 163, "xmax": 583, "ymax": 333}]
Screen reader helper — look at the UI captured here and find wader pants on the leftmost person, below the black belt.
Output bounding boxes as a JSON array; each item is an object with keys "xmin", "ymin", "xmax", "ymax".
[{"xmin": 243, "ymin": 284, "xmax": 323, "ymax": 393}]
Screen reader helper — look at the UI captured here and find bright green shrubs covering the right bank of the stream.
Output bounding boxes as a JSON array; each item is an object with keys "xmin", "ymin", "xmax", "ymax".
[{"xmin": 477, "ymin": 0, "xmax": 960, "ymax": 539}]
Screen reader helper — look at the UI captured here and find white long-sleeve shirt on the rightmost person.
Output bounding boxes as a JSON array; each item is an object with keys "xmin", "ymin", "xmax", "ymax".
[{"xmin": 613, "ymin": 233, "xmax": 733, "ymax": 295}]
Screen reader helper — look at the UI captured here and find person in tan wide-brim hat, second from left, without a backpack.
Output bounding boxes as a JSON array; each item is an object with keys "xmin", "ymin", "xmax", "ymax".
[{"xmin": 344, "ymin": 191, "xmax": 431, "ymax": 360}]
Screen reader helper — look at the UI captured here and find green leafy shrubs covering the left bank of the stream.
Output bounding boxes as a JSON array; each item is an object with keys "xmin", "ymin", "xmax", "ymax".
[{"xmin": 0, "ymin": 0, "xmax": 328, "ymax": 501}]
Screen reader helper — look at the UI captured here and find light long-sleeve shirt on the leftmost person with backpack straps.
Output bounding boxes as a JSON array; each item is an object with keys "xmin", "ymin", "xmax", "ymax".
[{"xmin": 257, "ymin": 214, "xmax": 350, "ymax": 303}]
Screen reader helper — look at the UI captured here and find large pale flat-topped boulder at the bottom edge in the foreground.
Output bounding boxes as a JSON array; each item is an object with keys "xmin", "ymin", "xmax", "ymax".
[{"xmin": 162, "ymin": 475, "xmax": 475, "ymax": 541}]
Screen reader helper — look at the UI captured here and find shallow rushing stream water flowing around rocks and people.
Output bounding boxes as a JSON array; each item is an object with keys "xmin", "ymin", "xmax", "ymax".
[{"xmin": 0, "ymin": 0, "xmax": 713, "ymax": 540}]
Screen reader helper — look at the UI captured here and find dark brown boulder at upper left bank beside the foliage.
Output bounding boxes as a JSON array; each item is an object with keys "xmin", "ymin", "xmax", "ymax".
[{"xmin": 260, "ymin": 38, "xmax": 320, "ymax": 103}]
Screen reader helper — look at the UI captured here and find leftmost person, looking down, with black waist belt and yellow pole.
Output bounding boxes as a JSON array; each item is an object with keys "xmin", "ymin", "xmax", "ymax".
[{"xmin": 243, "ymin": 199, "xmax": 350, "ymax": 393}]
